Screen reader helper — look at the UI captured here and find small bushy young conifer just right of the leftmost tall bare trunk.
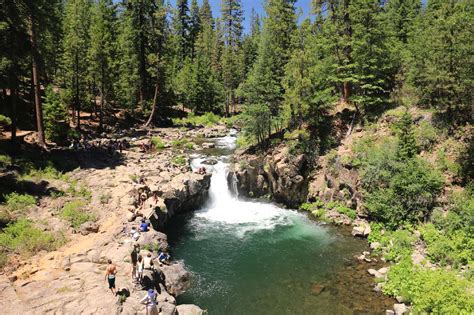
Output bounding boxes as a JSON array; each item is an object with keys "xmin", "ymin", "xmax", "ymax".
[{"xmin": 43, "ymin": 85, "xmax": 69, "ymax": 143}]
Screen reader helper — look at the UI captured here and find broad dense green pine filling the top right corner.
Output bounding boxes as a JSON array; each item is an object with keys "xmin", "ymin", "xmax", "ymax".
[{"xmin": 409, "ymin": 0, "xmax": 474, "ymax": 120}]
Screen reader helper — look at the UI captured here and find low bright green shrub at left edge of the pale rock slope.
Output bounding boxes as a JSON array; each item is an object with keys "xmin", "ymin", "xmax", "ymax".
[{"xmin": 0, "ymin": 219, "xmax": 65, "ymax": 255}]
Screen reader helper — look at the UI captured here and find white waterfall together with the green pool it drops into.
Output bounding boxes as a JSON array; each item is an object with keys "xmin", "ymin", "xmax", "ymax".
[{"xmin": 166, "ymin": 135, "xmax": 393, "ymax": 315}]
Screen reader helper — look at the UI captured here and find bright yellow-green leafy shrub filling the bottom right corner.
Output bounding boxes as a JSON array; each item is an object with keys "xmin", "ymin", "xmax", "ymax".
[{"xmin": 383, "ymin": 258, "xmax": 474, "ymax": 314}]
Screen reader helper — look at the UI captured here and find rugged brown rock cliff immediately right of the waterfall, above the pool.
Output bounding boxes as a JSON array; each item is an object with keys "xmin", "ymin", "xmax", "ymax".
[{"xmin": 227, "ymin": 146, "xmax": 311, "ymax": 207}]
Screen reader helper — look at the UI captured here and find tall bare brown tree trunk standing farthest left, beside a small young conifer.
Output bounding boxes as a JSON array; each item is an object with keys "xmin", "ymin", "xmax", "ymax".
[{"xmin": 30, "ymin": 12, "xmax": 46, "ymax": 147}]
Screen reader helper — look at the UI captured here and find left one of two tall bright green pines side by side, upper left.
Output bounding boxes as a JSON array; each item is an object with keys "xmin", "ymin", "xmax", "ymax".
[{"xmin": 62, "ymin": 0, "xmax": 91, "ymax": 129}]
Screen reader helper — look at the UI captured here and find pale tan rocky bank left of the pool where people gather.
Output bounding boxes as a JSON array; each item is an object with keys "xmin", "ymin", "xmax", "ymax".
[{"xmin": 0, "ymin": 126, "xmax": 227, "ymax": 314}]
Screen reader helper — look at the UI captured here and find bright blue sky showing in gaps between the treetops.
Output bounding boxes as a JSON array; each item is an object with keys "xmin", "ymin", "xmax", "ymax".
[{"xmin": 171, "ymin": 0, "xmax": 311, "ymax": 31}]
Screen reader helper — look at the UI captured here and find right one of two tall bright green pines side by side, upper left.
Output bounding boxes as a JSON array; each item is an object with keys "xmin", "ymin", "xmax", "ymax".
[{"xmin": 89, "ymin": 0, "xmax": 116, "ymax": 130}]
